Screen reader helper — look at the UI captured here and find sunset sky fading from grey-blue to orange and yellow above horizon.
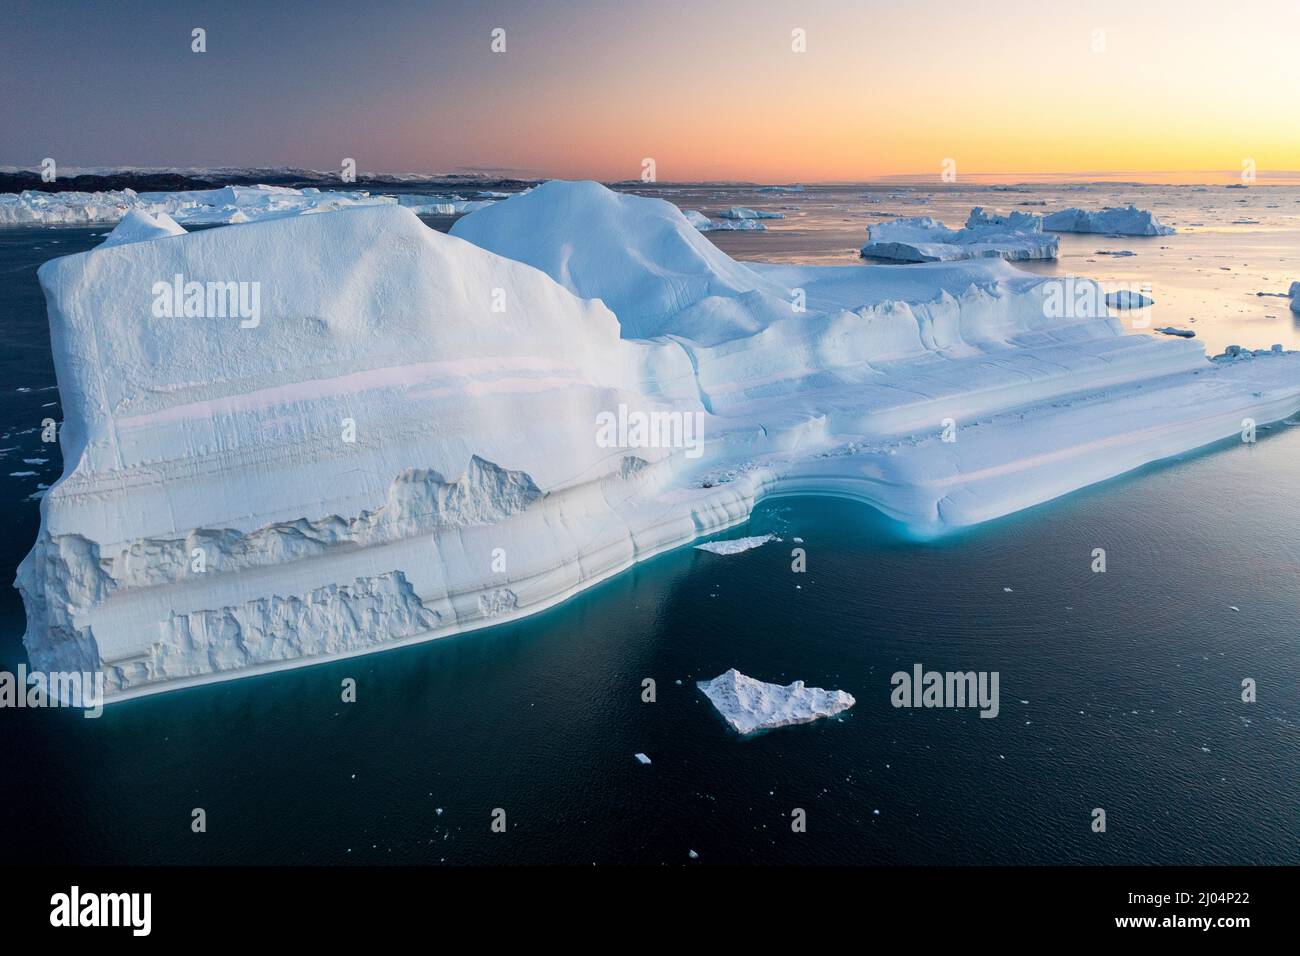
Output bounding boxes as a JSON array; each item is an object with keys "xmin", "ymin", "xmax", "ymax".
[{"xmin": 0, "ymin": 0, "xmax": 1300, "ymax": 182}]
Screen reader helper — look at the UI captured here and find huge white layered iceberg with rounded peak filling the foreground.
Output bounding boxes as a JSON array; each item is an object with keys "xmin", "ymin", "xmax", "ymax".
[{"xmin": 17, "ymin": 182, "xmax": 1300, "ymax": 700}]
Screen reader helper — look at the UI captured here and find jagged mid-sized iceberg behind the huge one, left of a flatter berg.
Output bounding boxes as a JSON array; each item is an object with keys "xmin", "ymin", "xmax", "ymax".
[{"xmin": 862, "ymin": 207, "xmax": 1061, "ymax": 263}]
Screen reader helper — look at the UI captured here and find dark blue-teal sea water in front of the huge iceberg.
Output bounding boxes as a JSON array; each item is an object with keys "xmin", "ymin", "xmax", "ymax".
[{"xmin": 0, "ymin": 221, "xmax": 1300, "ymax": 865}]
